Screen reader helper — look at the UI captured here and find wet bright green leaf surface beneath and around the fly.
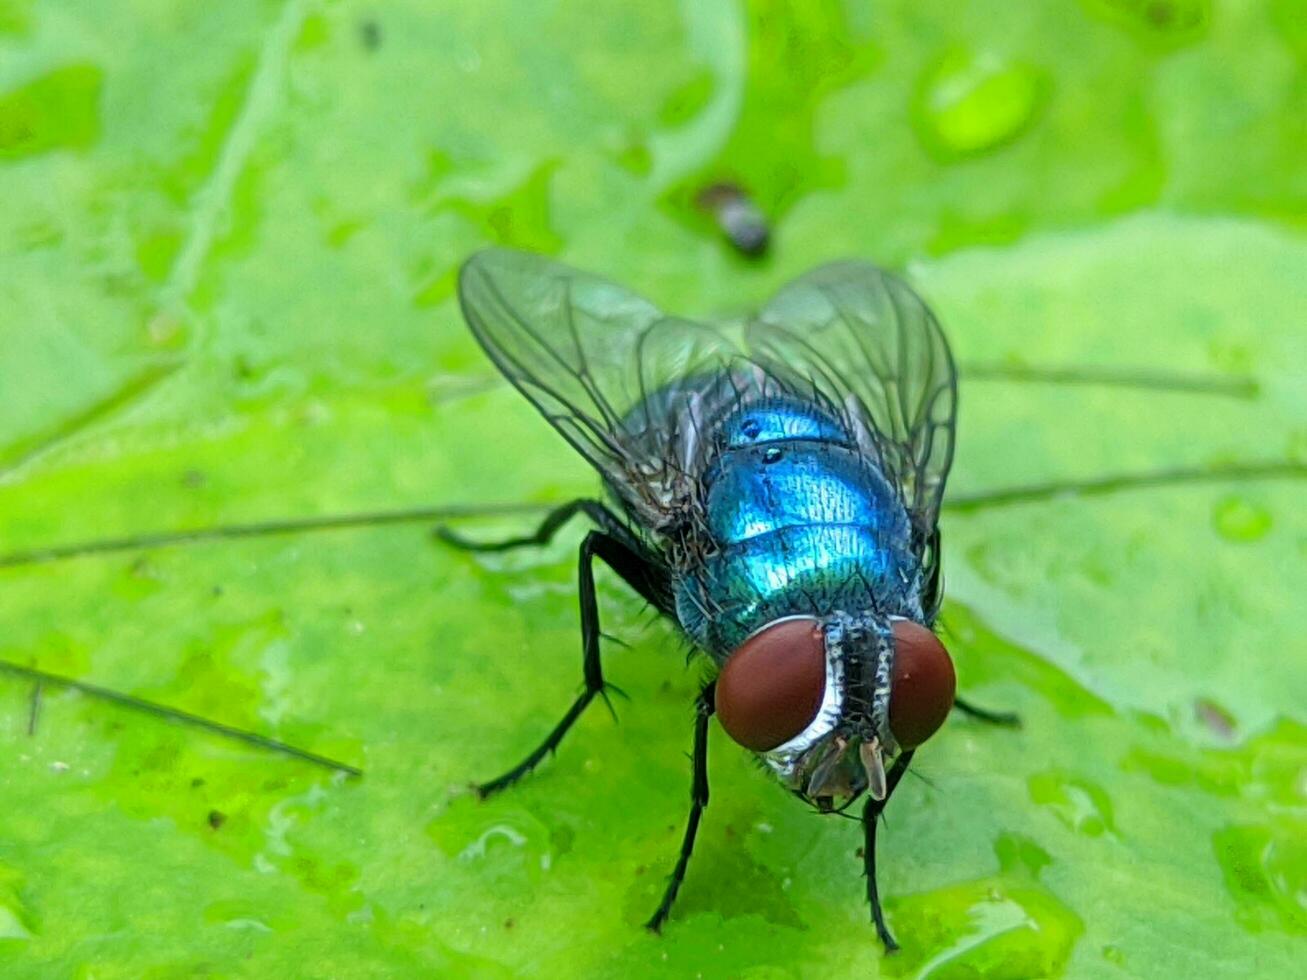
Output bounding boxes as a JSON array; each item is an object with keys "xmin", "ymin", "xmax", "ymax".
[{"xmin": 0, "ymin": 0, "xmax": 1307, "ymax": 979}]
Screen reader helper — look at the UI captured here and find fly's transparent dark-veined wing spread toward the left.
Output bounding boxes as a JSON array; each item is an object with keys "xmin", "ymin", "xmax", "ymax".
[{"xmin": 459, "ymin": 248, "xmax": 738, "ymax": 528}]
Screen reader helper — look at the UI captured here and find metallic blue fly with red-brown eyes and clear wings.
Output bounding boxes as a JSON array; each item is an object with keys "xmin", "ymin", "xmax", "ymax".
[{"xmin": 442, "ymin": 250, "xmax": 1010, "ymax": 950}]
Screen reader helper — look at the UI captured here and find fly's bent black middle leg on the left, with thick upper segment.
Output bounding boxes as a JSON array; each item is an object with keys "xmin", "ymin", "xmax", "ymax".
[{"xmin": 477, "ymin": 530, "xmax": 669, "ymax": 798}]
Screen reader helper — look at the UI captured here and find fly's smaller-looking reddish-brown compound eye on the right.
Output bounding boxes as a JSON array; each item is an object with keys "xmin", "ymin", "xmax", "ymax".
[{"xmin": 890, "ymin": 619, "xmax": 958, "ymax": 749}]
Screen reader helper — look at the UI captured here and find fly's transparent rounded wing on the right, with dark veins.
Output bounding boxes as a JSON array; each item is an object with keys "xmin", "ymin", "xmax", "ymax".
[{"xmin": 746, "ymin": 261, "xmax": 957, "ymax": 537}]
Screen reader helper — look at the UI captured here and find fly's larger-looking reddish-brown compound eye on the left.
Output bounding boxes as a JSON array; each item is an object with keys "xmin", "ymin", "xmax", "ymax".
[{"xmin": 716, "ymin": 618, "xmax": 826, "ymax": 753}]
